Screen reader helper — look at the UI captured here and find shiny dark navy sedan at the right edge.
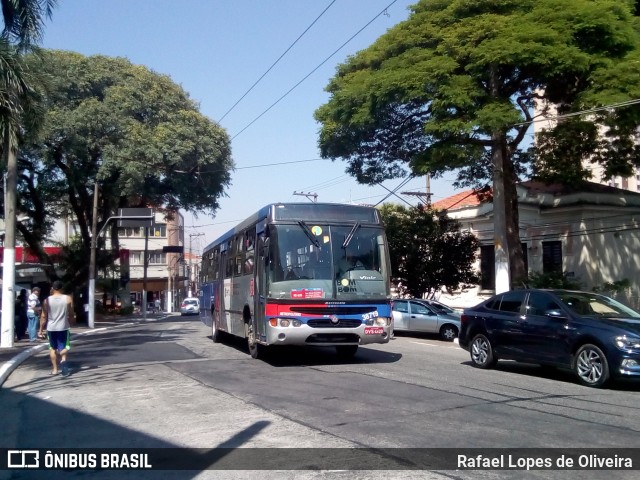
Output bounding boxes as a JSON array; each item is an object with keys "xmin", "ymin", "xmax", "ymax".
[{"xmin": 458, "ymin": 289, "xmax": 640, "ymax": 387}]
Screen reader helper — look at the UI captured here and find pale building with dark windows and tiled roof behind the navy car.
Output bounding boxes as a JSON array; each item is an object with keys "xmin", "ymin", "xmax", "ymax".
[{"xmin": 433, "ymin": 181, "xmax": 640, "ymax": 308}]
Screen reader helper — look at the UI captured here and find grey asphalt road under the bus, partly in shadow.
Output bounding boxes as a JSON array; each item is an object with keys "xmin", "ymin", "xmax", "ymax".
[{"xmin": 0, "ymin": 317, "xmax": 640, "ymax": 479}]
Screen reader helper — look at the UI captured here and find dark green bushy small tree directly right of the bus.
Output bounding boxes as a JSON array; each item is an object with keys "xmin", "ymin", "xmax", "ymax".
[{"xmin": 380, "ymin": 204, "xmax": 480, "ymax": 297}]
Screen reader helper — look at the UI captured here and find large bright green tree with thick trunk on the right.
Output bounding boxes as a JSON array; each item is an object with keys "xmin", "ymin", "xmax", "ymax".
[{"xmin": 316, "ymin": 0, "xmax": 640, "ymax": 290}]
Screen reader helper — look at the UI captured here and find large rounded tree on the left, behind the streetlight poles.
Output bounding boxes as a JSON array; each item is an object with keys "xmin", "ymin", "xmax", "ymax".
[{"xmin": 18, "ymin": 51, "xmax": 233, "ymax": 285}]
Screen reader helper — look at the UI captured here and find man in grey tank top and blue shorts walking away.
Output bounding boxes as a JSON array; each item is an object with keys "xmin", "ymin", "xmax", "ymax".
[{"xmin": 40, "ymin": 280, "xmax": 74, "ymax": 377}]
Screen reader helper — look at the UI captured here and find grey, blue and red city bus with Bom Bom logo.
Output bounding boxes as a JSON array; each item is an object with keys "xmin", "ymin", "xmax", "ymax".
[{"xmin": 199, "ymin": 203, "xmax": 391, "ymax": 358}]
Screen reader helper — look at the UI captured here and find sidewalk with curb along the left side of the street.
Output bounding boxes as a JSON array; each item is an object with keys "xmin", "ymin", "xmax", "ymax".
[{"xmin": 0, "ymin": 313, "xmax": 158, "ymax": 387}]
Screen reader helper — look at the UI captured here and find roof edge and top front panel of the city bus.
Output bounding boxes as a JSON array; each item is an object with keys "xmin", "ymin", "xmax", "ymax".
[{"xmin": 205, "ymin": 202, "xmax": 382, "ymax": 251}]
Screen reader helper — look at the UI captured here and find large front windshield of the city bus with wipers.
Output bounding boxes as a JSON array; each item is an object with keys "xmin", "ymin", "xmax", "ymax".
[{"xmin": 267, "ymin": 222, "xmax": 390, "ymax": 300}]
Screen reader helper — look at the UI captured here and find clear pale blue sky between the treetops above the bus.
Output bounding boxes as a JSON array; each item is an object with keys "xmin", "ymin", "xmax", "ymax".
[{"xmin": 43, "ymin": 0, "xmax": 455, "ymax": 253}]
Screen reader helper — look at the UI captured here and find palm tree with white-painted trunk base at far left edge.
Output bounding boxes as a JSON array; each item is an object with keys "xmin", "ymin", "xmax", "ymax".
[{"xmin": 0, "ymin": 0, "xmax": 57, "ymax": 347}]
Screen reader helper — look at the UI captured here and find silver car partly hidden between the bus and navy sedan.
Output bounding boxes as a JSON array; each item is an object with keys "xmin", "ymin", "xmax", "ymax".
[{"xmin": 392, "ymin": 299, "xmax": 460, "ymax": 342}]
